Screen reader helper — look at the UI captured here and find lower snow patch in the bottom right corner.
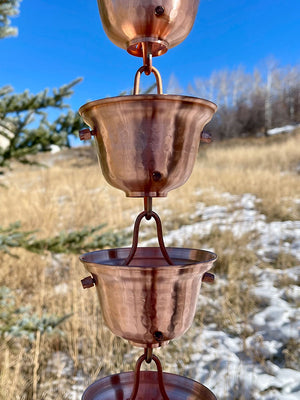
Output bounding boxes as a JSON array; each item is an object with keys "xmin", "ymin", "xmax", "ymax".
[{"xmin": 190, "ymin": 266, "xmax": 300, "ymax": 400}]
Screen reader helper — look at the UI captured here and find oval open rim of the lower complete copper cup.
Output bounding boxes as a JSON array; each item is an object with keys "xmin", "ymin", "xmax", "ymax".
[{"xmin": 79, "ymin": 247, "xmax": 218, "ymax": 271}]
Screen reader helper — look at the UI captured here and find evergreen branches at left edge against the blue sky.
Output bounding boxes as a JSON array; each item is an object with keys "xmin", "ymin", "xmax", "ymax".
[{"xmin": 0, "ymin": 0, "xmax": 82, "ymax": 173}]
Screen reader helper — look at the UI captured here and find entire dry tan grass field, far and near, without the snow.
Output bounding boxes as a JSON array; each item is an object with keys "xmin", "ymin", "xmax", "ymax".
[{"xmin": 0, "ymin": 132, "xmax": 300, "ymax": 400}]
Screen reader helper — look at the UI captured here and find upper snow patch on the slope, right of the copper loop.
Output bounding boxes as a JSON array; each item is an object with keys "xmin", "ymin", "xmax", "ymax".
[{"xmin": 143, "ymin": 193, "xmax": 300, "ymax": 261}]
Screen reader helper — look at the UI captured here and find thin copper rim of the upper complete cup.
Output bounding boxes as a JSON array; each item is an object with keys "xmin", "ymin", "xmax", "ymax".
[{"xmin": 78, "ymin": 94, "xmax": 218, "ymax": 115}]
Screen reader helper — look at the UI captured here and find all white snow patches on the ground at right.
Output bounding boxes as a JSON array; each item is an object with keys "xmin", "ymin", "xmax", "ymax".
[{"xmin": 143, "ymin": 193, "xmax": 300, "ymax": 400}]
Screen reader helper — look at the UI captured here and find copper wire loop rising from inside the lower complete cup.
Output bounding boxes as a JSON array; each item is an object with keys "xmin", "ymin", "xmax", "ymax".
[{"xmin": 123, "ymin": 211, "xmax": 173, "ymax": 265}]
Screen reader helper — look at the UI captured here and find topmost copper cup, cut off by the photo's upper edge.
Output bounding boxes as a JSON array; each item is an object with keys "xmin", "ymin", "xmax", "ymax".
[{"xmin": 98, "ymin": 0, "xmax": 199, "ymax": 57}]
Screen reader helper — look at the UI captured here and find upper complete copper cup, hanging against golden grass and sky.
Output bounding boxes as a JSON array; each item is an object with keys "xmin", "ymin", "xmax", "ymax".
[{"xmin": 79, "ymin": 94, "xmax": 217, "ymax": 197}]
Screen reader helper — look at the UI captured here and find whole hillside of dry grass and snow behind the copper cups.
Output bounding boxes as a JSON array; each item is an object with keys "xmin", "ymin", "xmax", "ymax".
[{"xmin": 0, "ymin": 130, "xmax": 300, "ymax": 400}]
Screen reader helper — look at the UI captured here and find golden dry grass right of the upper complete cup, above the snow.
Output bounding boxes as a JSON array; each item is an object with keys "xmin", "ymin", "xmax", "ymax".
[{"xmin": 173, "ymin": 132, "xmax": 300, "ymax": 219}]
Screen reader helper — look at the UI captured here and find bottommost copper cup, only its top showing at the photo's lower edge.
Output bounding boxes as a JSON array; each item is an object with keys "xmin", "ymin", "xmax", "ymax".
[{"xmin": 82, "ymin": 371, "xmax": 217, "ymax": 400}]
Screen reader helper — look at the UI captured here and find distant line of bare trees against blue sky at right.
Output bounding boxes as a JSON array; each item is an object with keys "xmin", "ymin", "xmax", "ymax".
[{"xmin": 188, "ymin": 60, "xmax": 300, "ymax": 139}]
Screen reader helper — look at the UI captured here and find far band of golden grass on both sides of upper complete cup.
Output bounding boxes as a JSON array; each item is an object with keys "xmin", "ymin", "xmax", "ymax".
[{"xmin": 0, "ymin": 132, "xmax": 300, "ymax": 236}]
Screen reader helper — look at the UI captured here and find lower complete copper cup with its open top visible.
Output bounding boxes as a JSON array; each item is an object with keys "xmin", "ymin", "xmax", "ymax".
[{"xmin": 80, "ymin": 247, "xmax": 217, "ymax": 347}]
